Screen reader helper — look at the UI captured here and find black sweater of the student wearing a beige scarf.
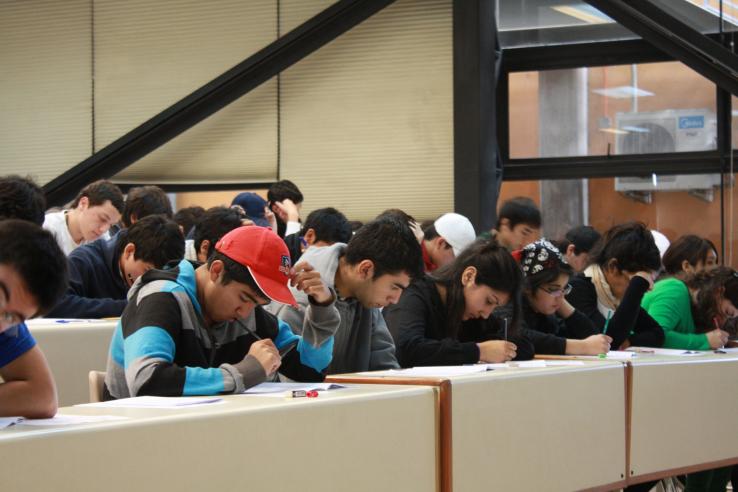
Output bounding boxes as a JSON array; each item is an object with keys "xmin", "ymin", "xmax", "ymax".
[{"xmin": 566, "ymin": 274, "xmax": 664, "ymax": 349}]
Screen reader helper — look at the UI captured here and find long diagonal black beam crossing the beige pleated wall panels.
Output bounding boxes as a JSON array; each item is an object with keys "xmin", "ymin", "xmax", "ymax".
[{"xmin": 43, "ymin": 0, "xmax": 394, "ymax": 206}]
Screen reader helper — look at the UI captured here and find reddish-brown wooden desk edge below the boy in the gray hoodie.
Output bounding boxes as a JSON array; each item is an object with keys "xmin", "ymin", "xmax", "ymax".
[{"xmin": 325, "ymin": 374, "xmax": 453, "ymax": 492}]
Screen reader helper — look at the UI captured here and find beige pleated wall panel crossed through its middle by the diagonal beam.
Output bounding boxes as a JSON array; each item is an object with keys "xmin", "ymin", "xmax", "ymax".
[{"xmin": 95, "ymin": 0, "xmax": 277, "ymax": 183}]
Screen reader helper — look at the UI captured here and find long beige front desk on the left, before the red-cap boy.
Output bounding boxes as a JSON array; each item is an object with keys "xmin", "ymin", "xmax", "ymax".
[{"xmin": 0, "ymin": 385, "xmax": 438, "ymax": 492}]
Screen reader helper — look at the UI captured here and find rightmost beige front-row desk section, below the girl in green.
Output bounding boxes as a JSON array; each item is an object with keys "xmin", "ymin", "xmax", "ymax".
[{"xmin": 630, "ymin": 353, "xmax": 738, "ymax": 477}]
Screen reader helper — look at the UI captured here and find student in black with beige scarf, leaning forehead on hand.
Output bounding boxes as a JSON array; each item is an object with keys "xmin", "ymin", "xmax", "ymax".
[{"xmin": 566, "ymin": 222, "xmax": 664, "ymax": 350}]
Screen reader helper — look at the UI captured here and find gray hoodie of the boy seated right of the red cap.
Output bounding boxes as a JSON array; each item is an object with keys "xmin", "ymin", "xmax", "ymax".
[{"xmin": 269, "ymin": 243, "xmax": 400, "ymax": 374}]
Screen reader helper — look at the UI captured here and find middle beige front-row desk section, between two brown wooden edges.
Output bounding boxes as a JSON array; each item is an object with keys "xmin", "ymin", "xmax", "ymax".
[{"xmin": 452, "ymin": 361, "xmax": 626, "ymax": 492}]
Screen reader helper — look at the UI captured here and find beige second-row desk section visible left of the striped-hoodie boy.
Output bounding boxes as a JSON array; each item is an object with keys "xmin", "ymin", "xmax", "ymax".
[{"xmin": 27, "ymin": 318, "xmax": 118, "ymax": 406}]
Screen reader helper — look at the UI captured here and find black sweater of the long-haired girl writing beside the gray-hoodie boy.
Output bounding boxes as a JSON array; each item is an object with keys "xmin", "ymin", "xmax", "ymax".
[{"xmin": 383, "ymin": 276, "xmax": 533, "ymax": 367}]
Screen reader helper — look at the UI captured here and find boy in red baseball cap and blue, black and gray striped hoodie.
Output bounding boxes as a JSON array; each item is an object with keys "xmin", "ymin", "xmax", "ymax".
[{"xmin": 104, "ymin": 226, "xmax": 340, "ymax": 399}]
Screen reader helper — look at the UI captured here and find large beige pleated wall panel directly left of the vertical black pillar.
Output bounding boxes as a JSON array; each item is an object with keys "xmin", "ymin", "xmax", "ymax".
[{"xmin": 280, "ymin": 0, "xmax": 453, "ymax": 220}]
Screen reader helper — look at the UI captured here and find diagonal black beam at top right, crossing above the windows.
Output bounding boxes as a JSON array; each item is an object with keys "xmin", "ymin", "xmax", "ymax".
[{"xmin": 586, "ymin": 0, "xmax": 738, "ymax": 95}]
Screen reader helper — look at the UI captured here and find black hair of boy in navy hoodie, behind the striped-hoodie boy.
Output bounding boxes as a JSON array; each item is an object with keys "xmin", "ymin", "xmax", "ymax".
[{"xmin": 116, "ymin": 215, "xmax": 184, "ymax": 268}]
